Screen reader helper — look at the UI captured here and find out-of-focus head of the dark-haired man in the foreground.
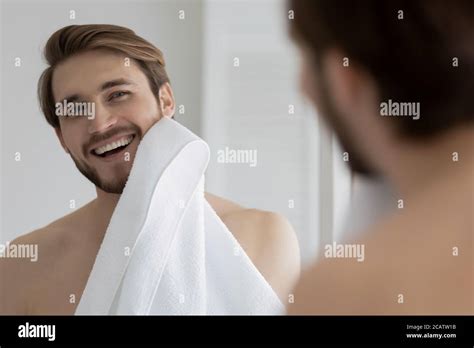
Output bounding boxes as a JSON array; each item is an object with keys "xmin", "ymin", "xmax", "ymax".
[{"xmin": 289, "ymin": 0, "xmax": 474, "ymax": 174}]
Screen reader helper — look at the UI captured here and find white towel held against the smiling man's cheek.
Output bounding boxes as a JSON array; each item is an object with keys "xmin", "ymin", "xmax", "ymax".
[{"xmin": 76, "ymin": 118, "xmax": 284, "ymax": 315}]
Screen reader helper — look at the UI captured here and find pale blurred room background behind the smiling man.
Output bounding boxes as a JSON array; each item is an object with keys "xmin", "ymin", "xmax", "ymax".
[{"xmin": 0, "ymin": 0, "xmax": 387, "ymax": 264}]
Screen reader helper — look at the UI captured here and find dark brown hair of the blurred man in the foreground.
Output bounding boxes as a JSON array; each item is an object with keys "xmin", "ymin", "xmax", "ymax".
[{"xmin": 288, "ymin": 0, "xmax": 474, "ymax": 138}]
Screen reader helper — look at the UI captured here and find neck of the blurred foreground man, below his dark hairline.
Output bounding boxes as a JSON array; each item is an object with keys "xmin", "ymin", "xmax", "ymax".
[{"xmin": 387, "ymin": 126, "xmax": 474, "ymax": 197}]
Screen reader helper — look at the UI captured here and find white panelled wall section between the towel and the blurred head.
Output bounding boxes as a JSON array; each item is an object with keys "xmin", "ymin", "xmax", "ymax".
[{"xmin": 203, "ymin": 0, "xmax": 326, "ymax": 261}]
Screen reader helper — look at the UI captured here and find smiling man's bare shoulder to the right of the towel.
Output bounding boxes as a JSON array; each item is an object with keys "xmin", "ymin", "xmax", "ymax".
[{"xmin": 206, "ymin": 194, "xmax": 300, "ymax": 302}]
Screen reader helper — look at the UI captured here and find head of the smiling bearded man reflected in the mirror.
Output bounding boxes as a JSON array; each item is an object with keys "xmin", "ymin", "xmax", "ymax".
[{"xmin": 38, "ymin": 25, "xmax": 174, "ymax": 193}]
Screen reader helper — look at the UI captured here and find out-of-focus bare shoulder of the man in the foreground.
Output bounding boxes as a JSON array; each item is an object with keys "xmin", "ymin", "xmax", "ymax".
[{"xmin": 288, "ymin": 185, "xmax": 474, "ymax": 315}]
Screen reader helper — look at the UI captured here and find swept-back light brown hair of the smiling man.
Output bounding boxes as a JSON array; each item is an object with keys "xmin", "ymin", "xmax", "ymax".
[{"xmin": 38, "ymin": 24, "xmax": 169, "ymax": 128}]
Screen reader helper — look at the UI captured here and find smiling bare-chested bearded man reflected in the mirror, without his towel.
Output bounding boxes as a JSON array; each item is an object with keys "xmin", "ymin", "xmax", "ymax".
[{"xmin": 0, "ymin": 25, "xmax": 299, "ymax": 314}]
